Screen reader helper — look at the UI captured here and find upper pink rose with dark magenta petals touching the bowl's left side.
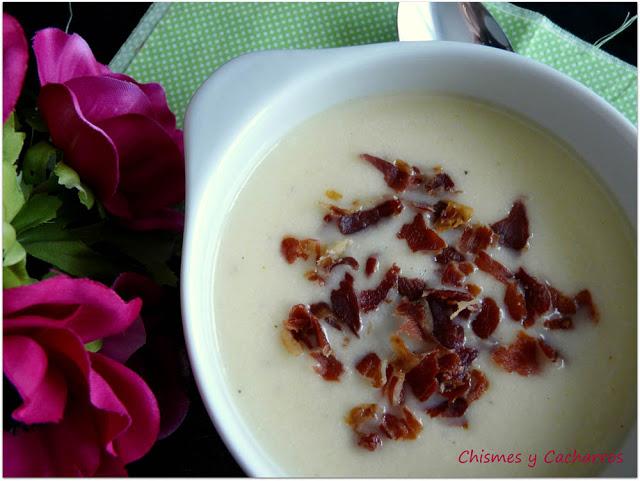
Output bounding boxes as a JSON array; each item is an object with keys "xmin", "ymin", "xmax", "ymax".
[{"xmin": 33, "ymin": 28, "xmax": 185, "ymax": 230}]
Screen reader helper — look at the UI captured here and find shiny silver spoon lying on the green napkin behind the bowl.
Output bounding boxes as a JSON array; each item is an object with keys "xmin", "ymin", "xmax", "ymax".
[{"xmin": 398, "ymin": 2, "xmax": 513, "ymax": 51}]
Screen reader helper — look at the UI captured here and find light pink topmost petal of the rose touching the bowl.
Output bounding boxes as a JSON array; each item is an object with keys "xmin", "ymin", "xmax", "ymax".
[{"xmin": 33, "ymin": 28, "xmax": 111, "ymax": 85}]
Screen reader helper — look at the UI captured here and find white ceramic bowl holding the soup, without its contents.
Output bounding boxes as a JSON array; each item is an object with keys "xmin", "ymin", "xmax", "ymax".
[{"xmin": 182, "ymin": 42, "xmax": 637, "ymax": 476}]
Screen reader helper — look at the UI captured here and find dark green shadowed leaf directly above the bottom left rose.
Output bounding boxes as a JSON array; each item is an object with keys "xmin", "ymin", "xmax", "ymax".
[{"xmin": 23, "ymin": 240, "xmax": 118, "ymax": 279}]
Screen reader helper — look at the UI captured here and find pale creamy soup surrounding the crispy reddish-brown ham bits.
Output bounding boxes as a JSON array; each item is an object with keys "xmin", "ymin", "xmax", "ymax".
[{"xmin": 212, "ymin": 94, "xmax": 636, "ymax": 477}]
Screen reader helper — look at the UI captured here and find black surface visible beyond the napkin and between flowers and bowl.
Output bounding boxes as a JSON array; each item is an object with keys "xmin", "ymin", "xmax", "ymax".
[{"xmin": 3, "ymin": 2, "xmax": 637, "ymax": 477}]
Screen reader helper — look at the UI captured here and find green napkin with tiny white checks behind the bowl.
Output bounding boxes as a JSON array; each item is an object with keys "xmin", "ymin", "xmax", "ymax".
[{"xmin": 111, "ymin": 2, "xmax": 638, "ymax": 125}]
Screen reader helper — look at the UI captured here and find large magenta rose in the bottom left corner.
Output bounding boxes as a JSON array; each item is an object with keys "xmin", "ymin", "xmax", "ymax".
[{"xmin": 3, "ymin": 275, "xmax": 160, "ymax": 476}]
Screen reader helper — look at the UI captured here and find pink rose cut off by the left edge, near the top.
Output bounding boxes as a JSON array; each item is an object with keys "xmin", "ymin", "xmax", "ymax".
[{"xmin": 2, "ymin": 12, "xmax": 29, "ymax": 123}]
